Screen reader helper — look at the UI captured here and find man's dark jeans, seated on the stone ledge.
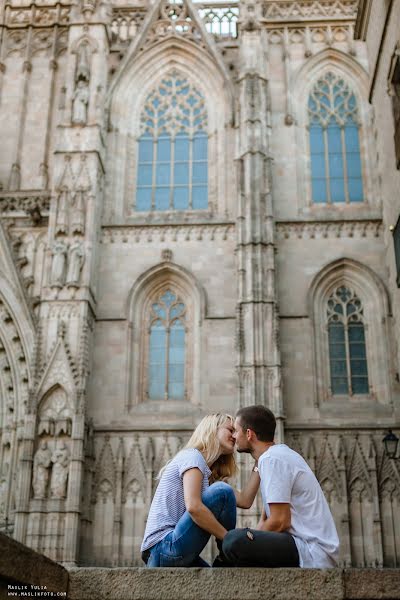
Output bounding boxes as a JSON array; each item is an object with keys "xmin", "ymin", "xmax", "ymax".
[{"xmin": 222, "ymin": 529, "xmax": 300, "ymax": 568}]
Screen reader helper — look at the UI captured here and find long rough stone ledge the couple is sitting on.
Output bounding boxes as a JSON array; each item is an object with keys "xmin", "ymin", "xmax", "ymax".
[{"xmin": 68, "ymin": 568, "xmax": 400, "ymax": 600}]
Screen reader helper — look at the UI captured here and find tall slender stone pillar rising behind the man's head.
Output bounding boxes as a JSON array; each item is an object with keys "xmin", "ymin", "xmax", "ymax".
[{"xmin": 237, "ymin": 0, "xmax": 284, "ymax": 440}]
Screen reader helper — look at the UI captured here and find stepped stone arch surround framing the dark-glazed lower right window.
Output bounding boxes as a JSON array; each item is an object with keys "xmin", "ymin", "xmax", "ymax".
[{"xmin": 308, "ymin": 258, "xmax": 391, "ymax": 411}]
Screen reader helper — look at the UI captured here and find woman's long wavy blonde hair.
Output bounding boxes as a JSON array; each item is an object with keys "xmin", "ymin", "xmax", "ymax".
[{"xmin": 185, "ymin": 413, "xmax": 237, "ymax": 481}]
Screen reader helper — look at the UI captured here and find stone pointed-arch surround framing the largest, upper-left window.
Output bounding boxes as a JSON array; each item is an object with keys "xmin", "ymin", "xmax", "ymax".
[{"xmin": 106, "ymin": 28, "xmax": 234, "ymax": 222}]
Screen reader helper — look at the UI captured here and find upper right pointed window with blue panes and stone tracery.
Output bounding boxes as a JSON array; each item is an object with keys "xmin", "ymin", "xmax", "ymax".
[{"xmin": 308, "ymin": 72, "xmax": 364, "ymax": 204}]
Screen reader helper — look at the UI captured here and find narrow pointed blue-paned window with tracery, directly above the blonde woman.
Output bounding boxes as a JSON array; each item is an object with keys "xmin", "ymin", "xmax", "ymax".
[{"xmin": 148, "ymin": 289, "xmax": 186, "ymax": 400}]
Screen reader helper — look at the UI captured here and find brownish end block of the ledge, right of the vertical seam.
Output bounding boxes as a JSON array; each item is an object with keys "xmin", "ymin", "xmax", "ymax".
[{"xmin": 344, "ymin": 569, "xmax": 400, "ymax": 600}]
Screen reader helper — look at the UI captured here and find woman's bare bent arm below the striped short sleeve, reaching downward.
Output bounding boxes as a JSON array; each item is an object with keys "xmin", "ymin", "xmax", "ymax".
[{"xmin": 183, "ymin": 468, "xmax": 228, "ymax": 540}]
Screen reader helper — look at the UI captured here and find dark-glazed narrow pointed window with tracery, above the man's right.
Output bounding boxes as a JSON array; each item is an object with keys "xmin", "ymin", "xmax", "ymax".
[{"xmin": 327, "ymin": 286, "xmax": 369, "ymax": 395}]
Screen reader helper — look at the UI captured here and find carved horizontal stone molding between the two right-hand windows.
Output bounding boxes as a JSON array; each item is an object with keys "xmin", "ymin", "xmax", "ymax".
[{"xmin": 276, "ymin": 219, "xmax": 383, "ymax": 240}]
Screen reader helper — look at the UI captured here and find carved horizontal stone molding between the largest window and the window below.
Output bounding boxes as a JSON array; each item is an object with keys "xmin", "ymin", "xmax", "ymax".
[{"xmin": 100, "ymin": 223, "xmax": 236, "ymax": 244}]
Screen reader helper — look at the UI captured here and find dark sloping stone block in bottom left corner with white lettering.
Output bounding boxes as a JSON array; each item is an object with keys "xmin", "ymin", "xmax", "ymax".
[{"xmin": 0, "ymin": 533, "xmax": 68, "ymax": 592}]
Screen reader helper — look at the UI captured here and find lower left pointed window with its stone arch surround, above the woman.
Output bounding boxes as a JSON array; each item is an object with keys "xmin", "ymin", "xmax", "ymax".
[{"xmin": 126, "ymin": 262, "xmax": 206, "ymax": 410}]
